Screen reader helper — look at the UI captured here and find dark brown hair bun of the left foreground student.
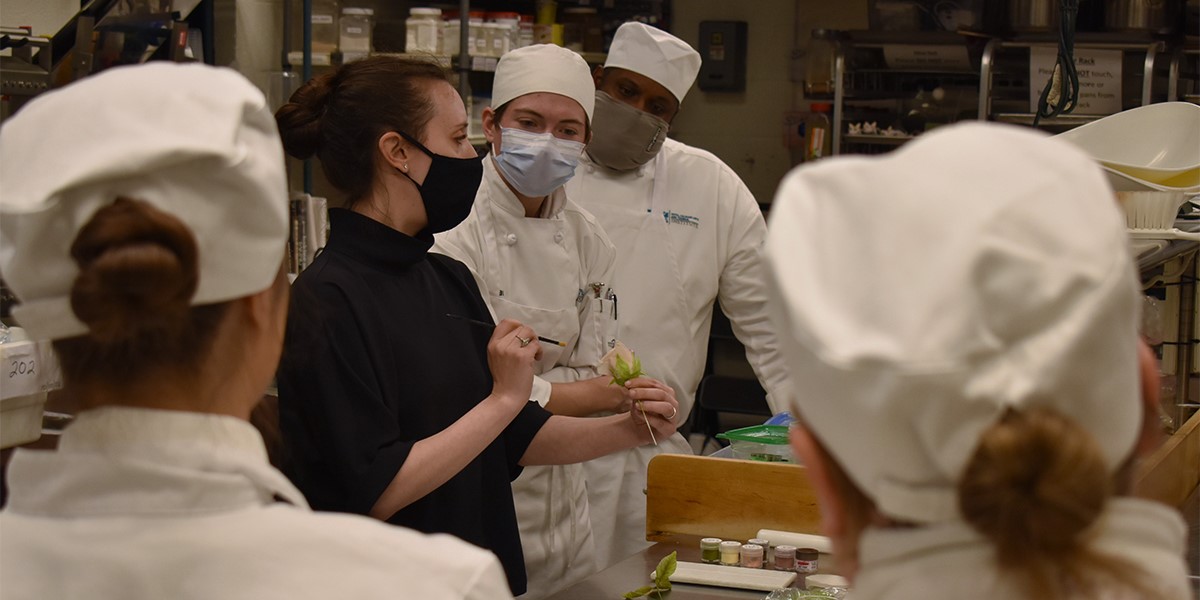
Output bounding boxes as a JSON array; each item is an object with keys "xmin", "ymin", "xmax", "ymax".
[{"xmin": 71, "ymin": 198, "xmax": 199, "ymax": 344}]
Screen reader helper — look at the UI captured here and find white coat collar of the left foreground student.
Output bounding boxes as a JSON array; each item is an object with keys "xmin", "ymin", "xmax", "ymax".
[{"xmin": 8, "ymin": 407, "xmax": 307, "ymax": 516}]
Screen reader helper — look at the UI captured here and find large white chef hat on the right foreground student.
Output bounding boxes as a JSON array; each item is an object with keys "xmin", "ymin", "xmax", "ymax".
[{"xmin": 766, "ymin": 124, "xmax": 1141, "ymax": 522}]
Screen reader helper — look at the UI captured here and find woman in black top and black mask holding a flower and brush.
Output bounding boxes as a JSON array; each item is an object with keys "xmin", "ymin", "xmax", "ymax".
[{"xmin": 276, "ymin": 56, "xmax": 678, "ymax": 594}]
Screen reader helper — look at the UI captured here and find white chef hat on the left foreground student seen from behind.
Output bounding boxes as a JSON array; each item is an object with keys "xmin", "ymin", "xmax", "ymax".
[{"xmin": 0, "ymin": 62, "xmax": 288, "ymax": 340}]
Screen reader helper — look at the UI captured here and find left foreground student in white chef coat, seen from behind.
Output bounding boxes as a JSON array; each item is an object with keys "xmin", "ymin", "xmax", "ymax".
[{"xmin": 0, "ymin": 62, "xmax": 511, "ymax": 600}]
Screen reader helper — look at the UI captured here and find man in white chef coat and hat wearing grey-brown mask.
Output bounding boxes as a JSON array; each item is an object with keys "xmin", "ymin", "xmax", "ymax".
[{"xmin": 565, "ymin": 23, "xmax": 787, "ymax": 568}]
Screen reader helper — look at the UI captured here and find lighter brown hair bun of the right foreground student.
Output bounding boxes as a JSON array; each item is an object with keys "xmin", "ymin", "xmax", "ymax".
[{"xmin": 959, "ymin": 408, "xmax": 1112, "ymax": 568}]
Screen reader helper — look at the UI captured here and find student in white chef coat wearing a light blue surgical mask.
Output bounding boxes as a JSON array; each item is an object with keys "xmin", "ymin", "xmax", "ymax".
[{"xmin": 433, "ymin": 44, "xmax": 673, "ymax": 600}]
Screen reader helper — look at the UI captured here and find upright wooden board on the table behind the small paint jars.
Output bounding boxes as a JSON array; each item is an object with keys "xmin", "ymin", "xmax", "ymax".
[{"xmin": 646, "ymin": 455, "xmax": 821, "ymax": 541}]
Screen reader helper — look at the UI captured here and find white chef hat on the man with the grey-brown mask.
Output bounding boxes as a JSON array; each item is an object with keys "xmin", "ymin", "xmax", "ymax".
[{"xmin": 604, "ymin": 22, "xmax": 700, "ymax": 102}]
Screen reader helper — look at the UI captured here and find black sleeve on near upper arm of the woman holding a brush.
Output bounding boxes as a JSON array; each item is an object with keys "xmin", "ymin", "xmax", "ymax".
[{"xmin": 278, "ymin": 276, "xmax": 416, "ymax": 514}]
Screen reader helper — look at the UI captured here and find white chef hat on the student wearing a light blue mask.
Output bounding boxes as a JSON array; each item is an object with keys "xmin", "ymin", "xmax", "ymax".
[{"xmin": 492, "ymin": 43, "xmax": 596, "ymax": 121}]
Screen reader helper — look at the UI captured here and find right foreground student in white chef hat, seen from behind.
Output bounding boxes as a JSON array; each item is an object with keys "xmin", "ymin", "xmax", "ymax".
[{"xmin": 767, "ymin": 124, "xmax": 1190, "ymax": 600}]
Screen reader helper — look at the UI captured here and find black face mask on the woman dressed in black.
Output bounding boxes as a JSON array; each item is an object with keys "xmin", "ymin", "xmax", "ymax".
[{"xmin": 396, "ymin": 131, "xmax": 487, "ymax": 234}]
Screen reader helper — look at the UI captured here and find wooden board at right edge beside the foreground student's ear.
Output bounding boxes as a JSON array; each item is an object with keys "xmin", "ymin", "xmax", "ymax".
[{"xmin": 1134, "ymin": 413, "xmax": 1200, "ymax": 508}]
